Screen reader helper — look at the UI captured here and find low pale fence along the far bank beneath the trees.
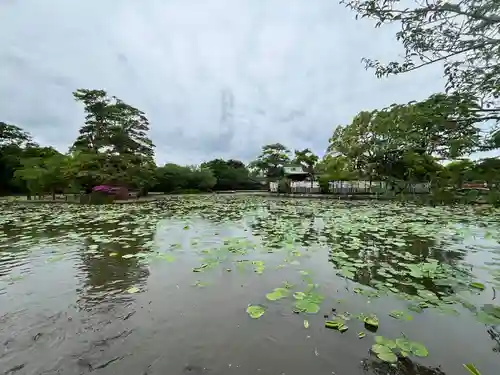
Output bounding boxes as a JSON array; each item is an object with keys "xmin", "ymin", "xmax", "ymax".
[{"xmin": 269, "ymin": 181, "xmax": 431, "ymax": 194}]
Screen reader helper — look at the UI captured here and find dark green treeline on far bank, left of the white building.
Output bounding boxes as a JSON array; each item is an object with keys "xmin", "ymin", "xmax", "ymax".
[{"xmin": 0, "ymin": 89, "xmax": 261, "ymax": 198}]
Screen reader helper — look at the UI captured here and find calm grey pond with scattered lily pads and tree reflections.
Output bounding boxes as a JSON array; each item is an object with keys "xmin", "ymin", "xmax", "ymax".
[{"xmin": 0, "ymin": 196, "xmax": 500, "ymax": 375}]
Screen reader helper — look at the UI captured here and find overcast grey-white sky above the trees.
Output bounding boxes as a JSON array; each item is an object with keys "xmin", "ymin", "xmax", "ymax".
[{"xmin": 0, "ymin": 0, "xmax": 444, "ymax": 164}]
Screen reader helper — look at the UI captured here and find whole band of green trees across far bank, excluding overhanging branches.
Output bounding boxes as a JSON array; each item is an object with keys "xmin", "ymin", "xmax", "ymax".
[{"xmin": 0, "ymin": 79, "xmax": 500, "ymax": 203}]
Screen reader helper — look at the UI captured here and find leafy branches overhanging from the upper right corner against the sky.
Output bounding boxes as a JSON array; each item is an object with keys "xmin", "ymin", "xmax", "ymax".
[{"xmin": 341, "ymin": 0, "xmax": 500, "ymax": 128}]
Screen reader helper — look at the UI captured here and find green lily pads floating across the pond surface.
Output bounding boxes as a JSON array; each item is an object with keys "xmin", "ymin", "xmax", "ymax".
[{"xmin": 0, "ymin": 196, "xmax": 500, "ymax": 371}]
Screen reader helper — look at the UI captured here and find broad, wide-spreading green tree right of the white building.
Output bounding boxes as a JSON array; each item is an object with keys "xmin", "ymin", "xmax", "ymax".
[{"xmin": 328, "ymin": 94, "xmax": 481, "ymax": 176}]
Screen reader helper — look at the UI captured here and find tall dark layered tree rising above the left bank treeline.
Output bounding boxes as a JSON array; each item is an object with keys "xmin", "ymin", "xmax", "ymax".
[{"xmin": 71, "ymin": 89, "xmax": 156, "ymax": 189}]
